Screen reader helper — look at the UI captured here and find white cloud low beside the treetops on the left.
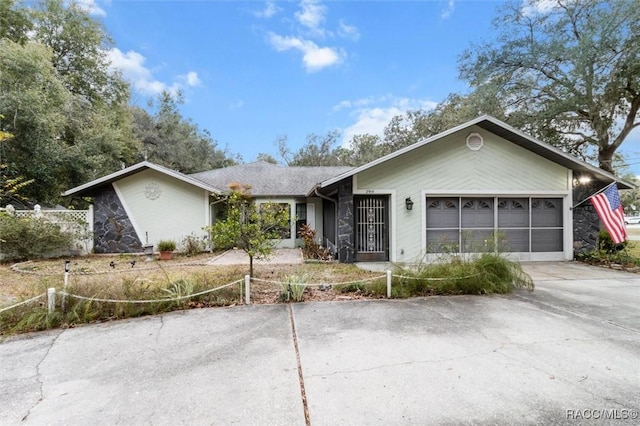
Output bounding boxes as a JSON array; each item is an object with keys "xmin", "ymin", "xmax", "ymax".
[{"xmin": 107, "ymin": 48, "xmax": 201, "ymax": 96}]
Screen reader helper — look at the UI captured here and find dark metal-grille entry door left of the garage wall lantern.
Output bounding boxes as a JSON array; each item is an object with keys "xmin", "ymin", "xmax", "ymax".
[{"xmin": 355, "ymin": 196, "xmax": 389, "ymax": 262}]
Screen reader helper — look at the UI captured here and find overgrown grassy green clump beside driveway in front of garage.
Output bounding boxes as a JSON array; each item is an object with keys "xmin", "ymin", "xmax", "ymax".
[{"xmin": 391, "ymin": 253, "xmax": 534, "ymax": 297}]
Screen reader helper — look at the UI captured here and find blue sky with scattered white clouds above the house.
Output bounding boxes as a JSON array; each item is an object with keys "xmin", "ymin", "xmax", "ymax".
[{"xmin": 75, "ymin": 0, "xmax": 640, "ymax": 174}]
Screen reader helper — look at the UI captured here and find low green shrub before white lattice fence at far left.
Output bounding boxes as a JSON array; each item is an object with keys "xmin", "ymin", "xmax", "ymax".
[{"xmin": 0, "ymin": 213, "xmax": 75, "ymax": 260}]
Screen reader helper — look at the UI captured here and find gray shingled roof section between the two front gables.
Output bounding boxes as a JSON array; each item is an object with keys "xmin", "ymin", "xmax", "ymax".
[{"xmin": 189, "ymin": 161, "xmax": 353, "ymax": 197}]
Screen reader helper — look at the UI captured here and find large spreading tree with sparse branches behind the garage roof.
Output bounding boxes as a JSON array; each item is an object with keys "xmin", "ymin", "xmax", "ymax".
[{"xmin": 459, "ymin": 0, "xmax": 640, "ymax": 172}]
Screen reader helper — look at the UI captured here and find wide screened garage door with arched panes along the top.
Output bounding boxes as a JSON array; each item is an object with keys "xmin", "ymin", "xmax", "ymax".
[{"xmin": 426, "ymin": 197, "xmax": 563, "ymax": 253}]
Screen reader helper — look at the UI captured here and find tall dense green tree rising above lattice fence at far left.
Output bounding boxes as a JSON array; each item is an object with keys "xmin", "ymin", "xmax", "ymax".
[{"xmin": 0, "ymin": 0, "xmax": 139, "ymax": 203}]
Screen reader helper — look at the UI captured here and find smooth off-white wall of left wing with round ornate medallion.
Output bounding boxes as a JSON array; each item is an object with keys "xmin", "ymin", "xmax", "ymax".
[{"xmin": 114, "ymin": 170, "xmax": 209, "ymax": 246}]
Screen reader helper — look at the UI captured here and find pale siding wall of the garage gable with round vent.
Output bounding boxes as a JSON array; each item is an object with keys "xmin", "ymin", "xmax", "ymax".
[{"xmin": 354, "ymin": 127, "xmax": 572, "ymax": 262}]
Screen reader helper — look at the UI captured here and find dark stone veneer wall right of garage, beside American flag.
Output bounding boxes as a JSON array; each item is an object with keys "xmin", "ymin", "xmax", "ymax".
[{"xmin": 573, "ymin": 183, "xmax": 602, "ymax": 256}]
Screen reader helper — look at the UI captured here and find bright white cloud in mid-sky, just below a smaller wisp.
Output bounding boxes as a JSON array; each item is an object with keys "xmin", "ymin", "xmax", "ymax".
[{"xmin": 269, "ymin": 33, "xmax": 344, "ymax": 72}]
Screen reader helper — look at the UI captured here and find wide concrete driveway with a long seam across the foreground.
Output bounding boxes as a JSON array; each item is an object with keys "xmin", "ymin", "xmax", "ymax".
[{"xmin": 0, "ymin": 263, "xmax": 640, "ymax": 425}]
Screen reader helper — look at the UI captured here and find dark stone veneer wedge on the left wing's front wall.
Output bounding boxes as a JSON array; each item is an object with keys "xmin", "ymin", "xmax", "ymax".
[{"xmin": 93, "ymin": 186, "xmax": 143, "ymax": 253}]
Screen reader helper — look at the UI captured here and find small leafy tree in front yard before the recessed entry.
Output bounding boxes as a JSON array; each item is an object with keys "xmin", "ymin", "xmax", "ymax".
[{"xmin": 206, "ymin": 184, "xmax": 289, "ymax": 276}]
